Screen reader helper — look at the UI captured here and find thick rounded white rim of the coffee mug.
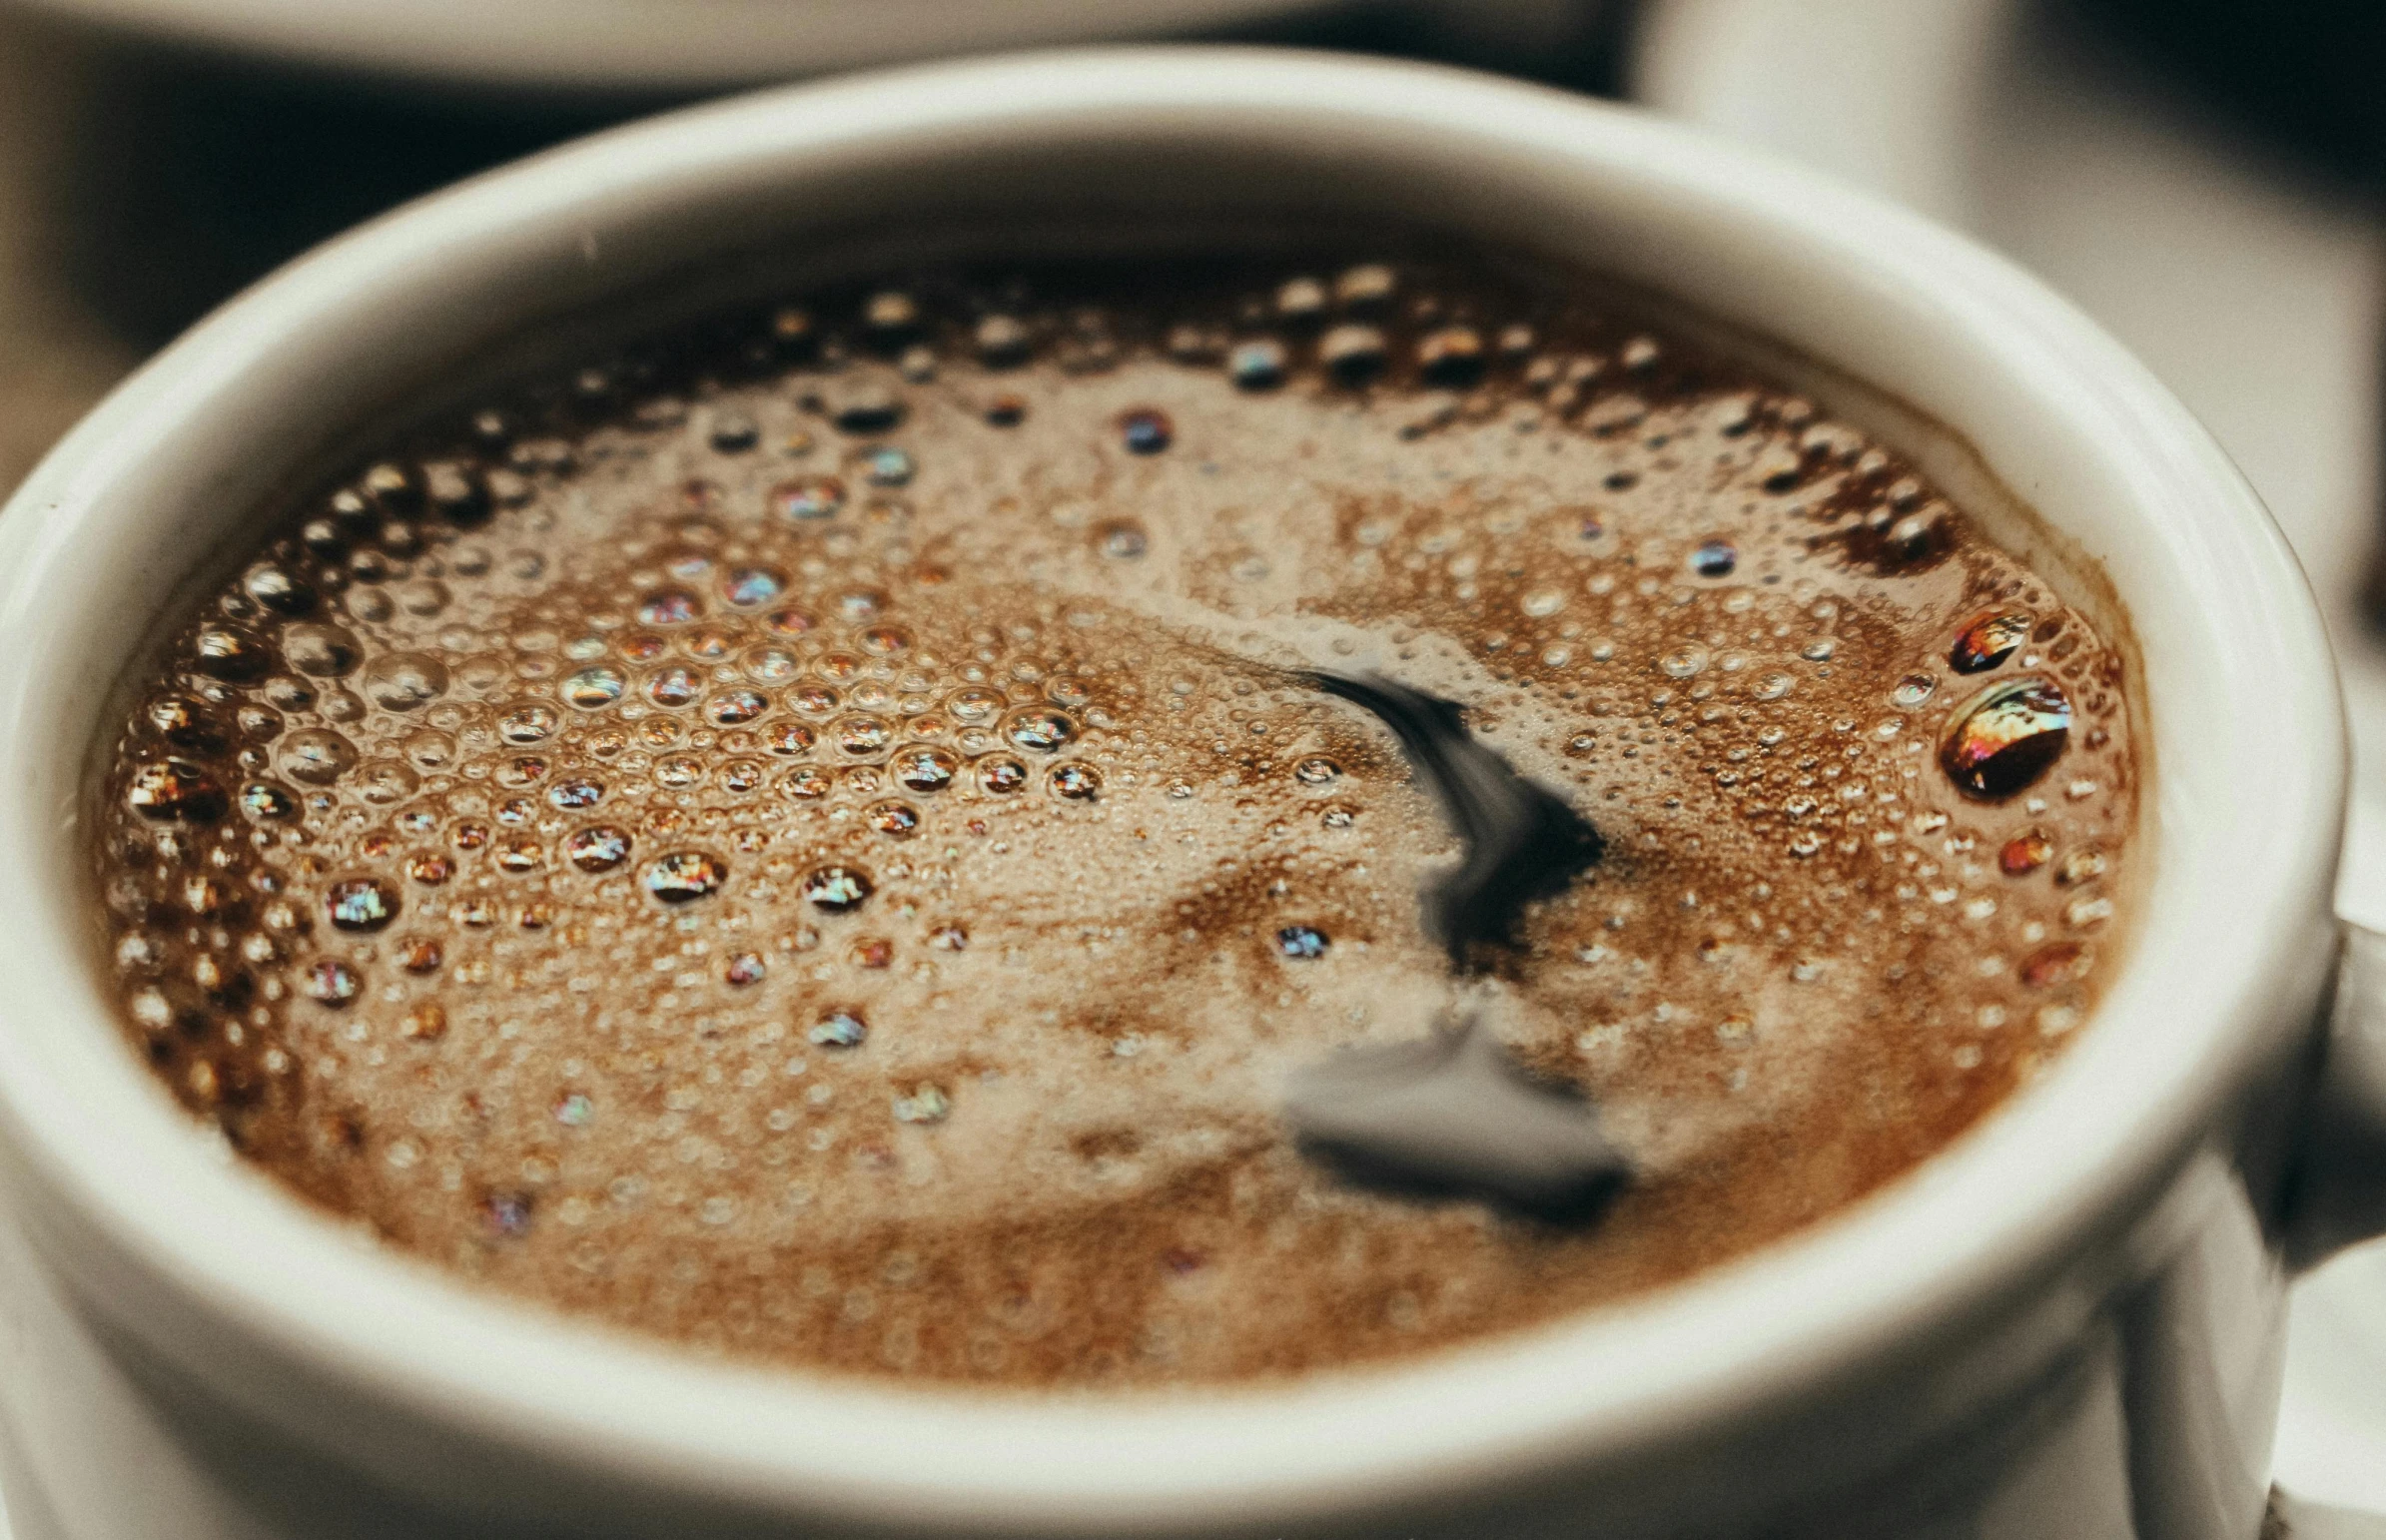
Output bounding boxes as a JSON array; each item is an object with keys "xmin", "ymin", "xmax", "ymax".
[{"xmin": 0, "ymin": 48, "xmax": 2343, "ymax": 1530}]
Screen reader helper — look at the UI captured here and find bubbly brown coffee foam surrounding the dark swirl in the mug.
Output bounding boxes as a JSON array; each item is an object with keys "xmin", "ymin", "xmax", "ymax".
[{"xmin": 96, "ymin": 258, "xmax": 2142, "ymax": 1385}]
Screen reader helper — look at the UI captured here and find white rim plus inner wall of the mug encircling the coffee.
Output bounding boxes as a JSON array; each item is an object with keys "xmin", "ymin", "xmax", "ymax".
[{"xmin": 0, "ymin": 55, "xmax": 2341, "ymax": 1523}]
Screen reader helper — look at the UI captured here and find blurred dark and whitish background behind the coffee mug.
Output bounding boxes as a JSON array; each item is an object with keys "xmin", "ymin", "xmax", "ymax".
[{"xmin": 0, "ymin": 0, "xmax": 2386, "ymax": 1540}]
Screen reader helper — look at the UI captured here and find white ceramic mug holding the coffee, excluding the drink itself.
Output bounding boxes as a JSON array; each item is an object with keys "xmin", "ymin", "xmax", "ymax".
[{"xmin": 0, "ymin": 50, "xmax": 2386, "ymax": 1540}]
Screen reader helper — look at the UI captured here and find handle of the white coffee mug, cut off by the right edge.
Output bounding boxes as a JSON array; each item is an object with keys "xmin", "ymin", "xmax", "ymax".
[{"xmin": 2286, "ymin": 919, "xmax": 2386, "ymax": 1270}]
